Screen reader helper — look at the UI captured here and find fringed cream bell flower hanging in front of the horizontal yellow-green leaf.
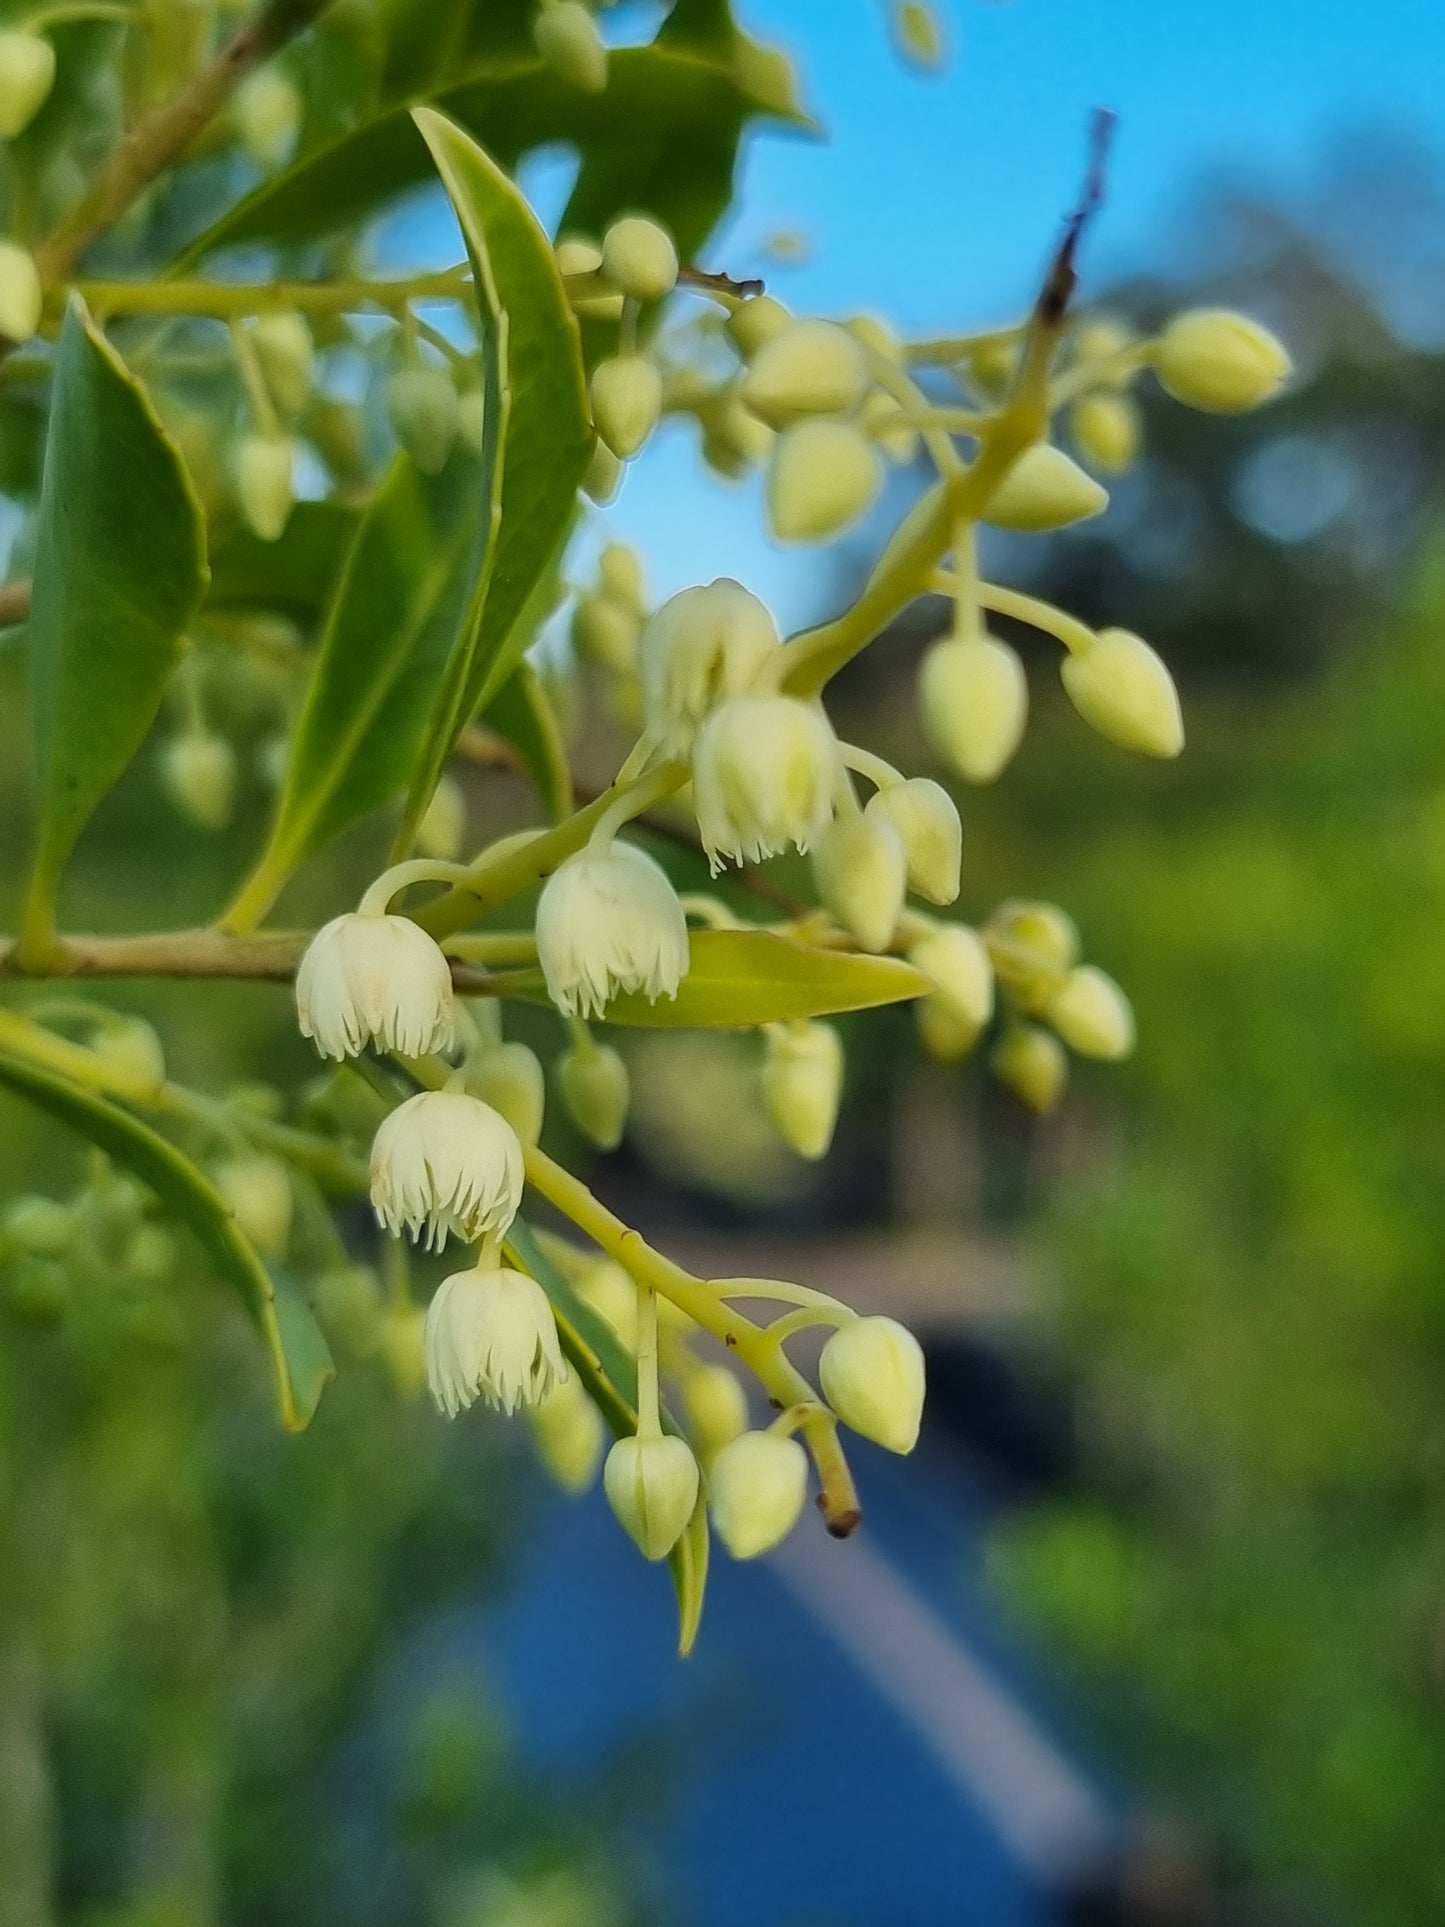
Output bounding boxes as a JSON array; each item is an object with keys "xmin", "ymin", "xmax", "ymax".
[{"xmin": 538, "ymin": 842, "xmax": 688, "ymax": 1017}]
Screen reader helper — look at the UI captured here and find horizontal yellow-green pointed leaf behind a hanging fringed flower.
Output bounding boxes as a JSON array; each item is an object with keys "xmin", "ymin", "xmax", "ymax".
[{"xmin": 507, "ymin": 931, "xmax": 933, "ymax": 1031}]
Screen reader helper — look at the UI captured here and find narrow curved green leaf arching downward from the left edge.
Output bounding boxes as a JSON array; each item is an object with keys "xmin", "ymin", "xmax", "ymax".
[{"xmin": 0, "ymin": 1054, "xmax": 335, "ymax": 1432}]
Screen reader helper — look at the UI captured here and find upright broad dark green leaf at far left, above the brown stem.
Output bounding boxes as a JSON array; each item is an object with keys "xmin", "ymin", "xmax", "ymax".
[{"xmin": 25, "ymin": 299, "xmax": 206, "ymax": 954}]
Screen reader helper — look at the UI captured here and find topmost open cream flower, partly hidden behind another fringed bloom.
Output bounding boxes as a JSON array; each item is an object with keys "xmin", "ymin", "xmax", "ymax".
[{"xmin": 638, "ymin": 576, "xmax": 782, "ymax": 755}]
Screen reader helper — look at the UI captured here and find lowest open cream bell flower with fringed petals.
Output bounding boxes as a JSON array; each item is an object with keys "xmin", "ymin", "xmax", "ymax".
[{"xmin": 424, "ymin": 1266, "xmax": 566, "ymax": 1418}]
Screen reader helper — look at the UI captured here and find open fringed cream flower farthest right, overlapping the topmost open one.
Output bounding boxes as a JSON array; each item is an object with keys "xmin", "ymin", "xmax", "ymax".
[{"xmin": 692, "ymin": 696, "xmax": 838, "ymax": 873}]
